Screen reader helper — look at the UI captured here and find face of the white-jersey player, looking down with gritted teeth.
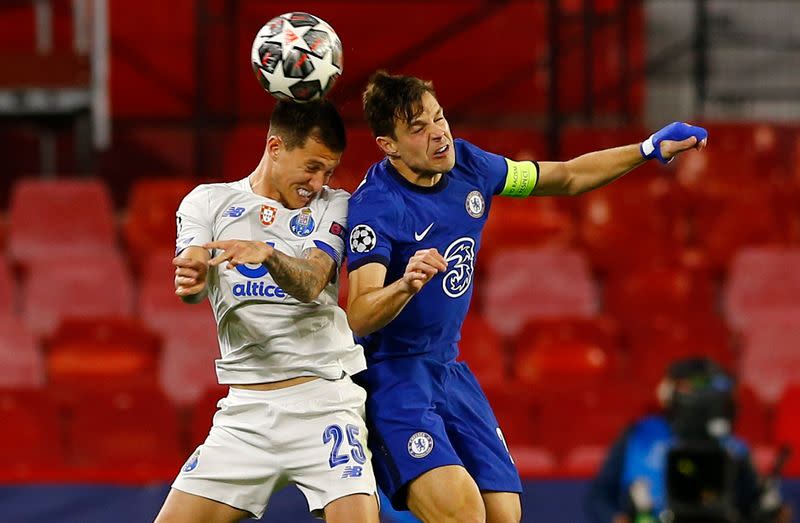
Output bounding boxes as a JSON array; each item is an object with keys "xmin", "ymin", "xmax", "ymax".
[{"xmin": 269, "ymin": 136, "xmax": 342, "ymax": 209}]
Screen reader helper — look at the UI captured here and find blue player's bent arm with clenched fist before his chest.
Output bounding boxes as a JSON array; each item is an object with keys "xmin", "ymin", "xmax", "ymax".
[{"xmin": 347, "ymin": 249, "xmax": 447, "ymax": 336}]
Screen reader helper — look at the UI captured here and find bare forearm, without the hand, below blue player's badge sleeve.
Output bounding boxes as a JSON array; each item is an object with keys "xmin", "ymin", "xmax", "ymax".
[{"xmin": 347, "ymin": 280, "xmax": 414, "ymax": 336}]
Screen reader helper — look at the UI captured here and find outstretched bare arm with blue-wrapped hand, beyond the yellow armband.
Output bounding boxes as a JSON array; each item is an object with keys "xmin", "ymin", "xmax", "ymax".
[{"xmin": 533, "ymin": 122, "xmax": 708, "ymax": 196}]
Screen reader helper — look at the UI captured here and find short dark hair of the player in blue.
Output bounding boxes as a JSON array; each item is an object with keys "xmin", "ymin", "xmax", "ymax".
[{"xmin": 363, "ymin": 71, "xmax": 436, "ymax": 138}]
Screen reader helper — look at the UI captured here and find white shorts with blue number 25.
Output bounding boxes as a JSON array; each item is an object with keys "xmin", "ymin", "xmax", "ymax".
[{"xmin": 172, "ymin": 376, "xmax": 377, "ymax": 518}]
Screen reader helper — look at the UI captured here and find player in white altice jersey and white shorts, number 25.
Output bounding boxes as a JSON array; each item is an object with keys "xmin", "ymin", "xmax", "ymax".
[{"xmin": 156, "ymin": 101, "xmax": 378, "ymax": 523}]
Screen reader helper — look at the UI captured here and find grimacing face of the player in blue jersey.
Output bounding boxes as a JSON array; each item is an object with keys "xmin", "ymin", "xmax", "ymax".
[{"xmin": 392, "ymin": 93, "xmax": 456, "ymax": 176}]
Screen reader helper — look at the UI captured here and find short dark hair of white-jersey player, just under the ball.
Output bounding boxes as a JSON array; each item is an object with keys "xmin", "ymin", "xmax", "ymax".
[{"xmin": 269, "ymin": 100, "xmax": 347, "ymax": 153}]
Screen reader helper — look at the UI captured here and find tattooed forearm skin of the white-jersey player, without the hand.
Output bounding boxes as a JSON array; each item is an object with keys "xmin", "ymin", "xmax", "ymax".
[{"xmin": 264, "ymin": 249, "xmax": 335, "ymax": 303}]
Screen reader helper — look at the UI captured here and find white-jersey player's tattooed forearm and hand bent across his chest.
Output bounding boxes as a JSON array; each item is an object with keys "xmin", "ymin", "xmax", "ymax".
[{"xmin": 203, "ymin": 240, "xmax": 336, "ymax": 303}]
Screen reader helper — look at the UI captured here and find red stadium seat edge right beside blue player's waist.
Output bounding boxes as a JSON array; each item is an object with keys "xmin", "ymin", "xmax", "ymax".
[{"xmin": 458, "ymin": 313, "xmax": 508, "ymax": 386}]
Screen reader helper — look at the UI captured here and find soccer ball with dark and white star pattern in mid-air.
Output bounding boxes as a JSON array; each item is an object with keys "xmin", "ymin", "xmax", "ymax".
[{"xmin": 251, "ymin": 13, "xmax": 342, "ymax": 102}]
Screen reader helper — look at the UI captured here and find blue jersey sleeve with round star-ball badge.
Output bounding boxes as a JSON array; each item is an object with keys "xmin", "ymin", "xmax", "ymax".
[{"xmin": 347, "ymin": 190, "xmax": 400, "ymax": 272}]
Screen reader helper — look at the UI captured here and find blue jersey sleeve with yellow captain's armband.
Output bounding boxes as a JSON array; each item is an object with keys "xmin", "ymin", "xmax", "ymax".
[{"xmin": 456, "ymin": 138, "xmax": 539, "ymax": 198}]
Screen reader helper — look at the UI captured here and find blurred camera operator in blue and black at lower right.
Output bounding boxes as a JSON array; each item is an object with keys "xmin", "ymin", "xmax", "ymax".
[{"xmin": 585, "ymin": 358, "xmax": 791, "ymax": 523}]
